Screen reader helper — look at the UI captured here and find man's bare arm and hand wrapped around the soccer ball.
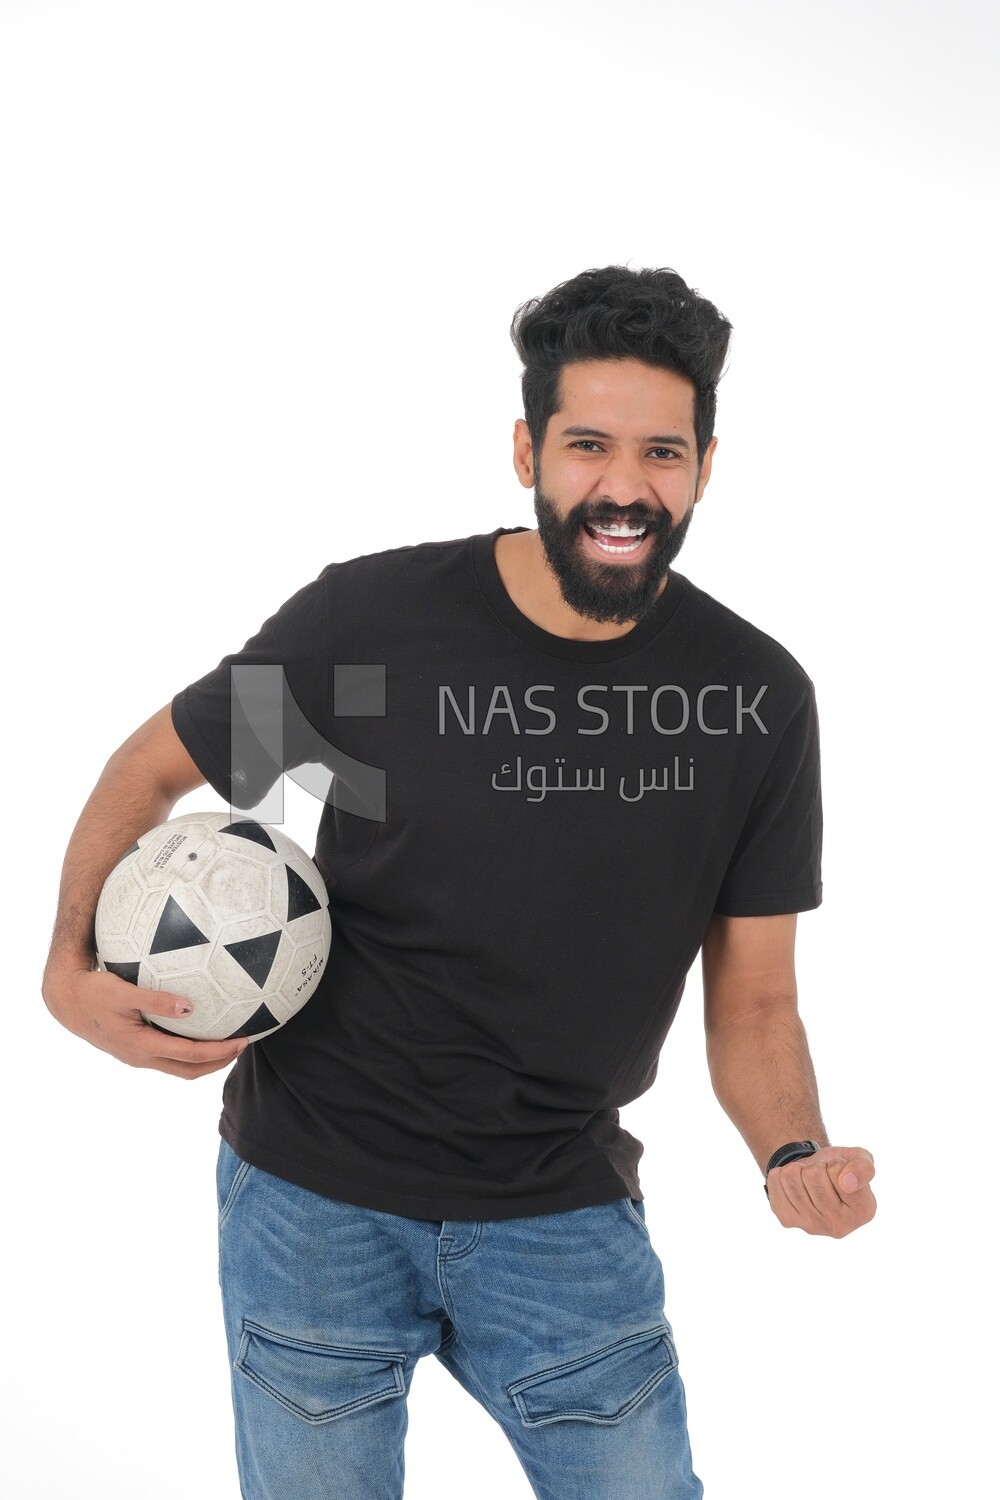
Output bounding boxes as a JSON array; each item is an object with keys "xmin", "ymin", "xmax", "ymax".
[{"xmin": 42, "ymin": 705, "xmax": 247, "ymax": 1079}]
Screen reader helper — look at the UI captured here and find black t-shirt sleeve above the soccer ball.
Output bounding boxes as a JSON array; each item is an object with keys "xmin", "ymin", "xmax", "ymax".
[{"xmin": 171, "ymin": 570, "xmax": 333, "ymax": 809}]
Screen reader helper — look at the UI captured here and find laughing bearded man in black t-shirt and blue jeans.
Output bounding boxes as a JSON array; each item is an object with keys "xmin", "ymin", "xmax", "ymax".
[{"xmin": 43, "ymin": 266, "xmax": 876, "ymax": 1500}]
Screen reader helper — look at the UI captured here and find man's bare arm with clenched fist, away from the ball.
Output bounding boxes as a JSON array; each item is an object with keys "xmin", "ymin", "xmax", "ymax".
[{"xmin": 702, "ymin": 912, "xmax": 876, "ymax": 1239}]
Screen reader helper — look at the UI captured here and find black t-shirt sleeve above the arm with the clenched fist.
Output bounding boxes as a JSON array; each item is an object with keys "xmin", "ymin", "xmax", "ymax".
[{"xmin": 714, "ymin": 680, "xmax": 823, "ymax": 917}]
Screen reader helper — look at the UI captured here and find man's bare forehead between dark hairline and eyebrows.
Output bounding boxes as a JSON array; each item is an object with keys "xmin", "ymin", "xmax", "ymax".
[{"xmin": 559, "ymin": 360, "xmax": 694, "ymax": 437}]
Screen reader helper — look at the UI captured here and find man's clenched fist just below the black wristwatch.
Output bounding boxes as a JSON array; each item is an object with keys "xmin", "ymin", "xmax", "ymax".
[{"xmin": 757, "ymin": 1146, "xmax": 876, "ymax": 1239}]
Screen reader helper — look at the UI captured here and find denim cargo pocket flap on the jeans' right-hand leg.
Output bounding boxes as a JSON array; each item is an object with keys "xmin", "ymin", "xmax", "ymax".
[{"xmin": 507, "ymin": 1323, "xmax": 678, "ymax": 1427}]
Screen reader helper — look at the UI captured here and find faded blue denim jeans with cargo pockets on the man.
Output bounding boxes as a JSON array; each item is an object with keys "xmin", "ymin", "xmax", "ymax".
[{"xmin": 217, "ymin": 1140, "xmax": 705, "ymax": 1500}]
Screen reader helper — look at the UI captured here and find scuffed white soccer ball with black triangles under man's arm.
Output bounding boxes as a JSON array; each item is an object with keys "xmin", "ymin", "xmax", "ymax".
[{"xmin": 96, "ymin": 813, "xmax": 331, "ymax": 1041}]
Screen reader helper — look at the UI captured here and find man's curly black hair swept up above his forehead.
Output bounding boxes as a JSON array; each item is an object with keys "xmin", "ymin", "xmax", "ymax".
[{"xmin": 510, "ymin": 266, "xmax": 733, "ymax": 468}]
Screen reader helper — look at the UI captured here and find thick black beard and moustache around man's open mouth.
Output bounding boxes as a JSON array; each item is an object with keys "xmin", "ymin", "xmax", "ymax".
[{"xmin": 535, "ymin": 485, "xmax": 694, "ymax": 626}]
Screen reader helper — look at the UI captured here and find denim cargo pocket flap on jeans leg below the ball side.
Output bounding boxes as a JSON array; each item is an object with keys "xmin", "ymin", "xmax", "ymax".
[{"xmin": 235, "ymin": 1320, "xmax": 406, "ymax": 1422}]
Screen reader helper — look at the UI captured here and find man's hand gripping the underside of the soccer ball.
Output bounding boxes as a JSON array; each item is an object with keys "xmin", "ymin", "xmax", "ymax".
[{"xmin": 42, "ymin": 969, "xmax": 247, "ymax": 1079}]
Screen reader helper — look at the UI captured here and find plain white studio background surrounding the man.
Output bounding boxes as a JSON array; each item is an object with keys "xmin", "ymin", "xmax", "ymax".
[{"xmin": 0, "ymin": 0, "xmax": 997, "ymax": 1500}]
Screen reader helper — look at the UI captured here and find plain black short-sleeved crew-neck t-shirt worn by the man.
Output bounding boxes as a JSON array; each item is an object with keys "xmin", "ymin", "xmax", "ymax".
[{"xmin": 172, "ymin": 527, "xmax": 822, "ymax": 1220}]
